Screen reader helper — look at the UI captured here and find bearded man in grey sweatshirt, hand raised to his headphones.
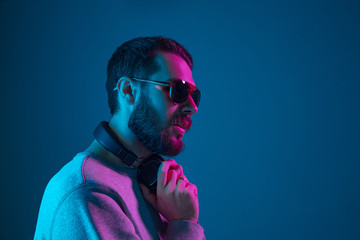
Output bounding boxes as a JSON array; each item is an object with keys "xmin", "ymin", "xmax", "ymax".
[{"xmin": 35, "ymin": 37, "xmax": 205, "ymax": 239}]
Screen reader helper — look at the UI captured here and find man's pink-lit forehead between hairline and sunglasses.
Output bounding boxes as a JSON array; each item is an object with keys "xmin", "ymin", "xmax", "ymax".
[{"xmin": 150, "ymin": 53, "xmax": 195, "ymax": 85}]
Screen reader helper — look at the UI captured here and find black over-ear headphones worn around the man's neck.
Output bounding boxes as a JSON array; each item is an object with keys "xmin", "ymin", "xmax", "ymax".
[{"xmin": 94, "ymin": 121, "xmax": 164, "ymax": 194}]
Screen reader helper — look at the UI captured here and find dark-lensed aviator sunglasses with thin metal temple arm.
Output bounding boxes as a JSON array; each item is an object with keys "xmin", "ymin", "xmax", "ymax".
[{"xmin": 114, "ymin": 78, "xmax": 201, "ymax": 107}]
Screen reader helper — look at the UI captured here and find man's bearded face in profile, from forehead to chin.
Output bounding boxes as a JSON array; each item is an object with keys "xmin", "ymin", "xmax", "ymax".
[{"xmin": 128, "ymin": 53, "xmax": 197, "ymax": 156}]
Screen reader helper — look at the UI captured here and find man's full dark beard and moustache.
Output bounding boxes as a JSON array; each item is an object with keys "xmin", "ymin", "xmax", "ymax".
[{"xmin": 128, "ymin": 94, "xmax": 191, "ymax": 156}]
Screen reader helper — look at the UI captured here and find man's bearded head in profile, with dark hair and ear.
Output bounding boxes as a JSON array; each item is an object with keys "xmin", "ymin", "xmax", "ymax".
[{"xmin": 107, "ymin": 37, "xmax": 197, "ymax": 156}]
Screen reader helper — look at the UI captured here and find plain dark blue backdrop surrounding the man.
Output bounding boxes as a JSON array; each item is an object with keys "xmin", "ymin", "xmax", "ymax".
[{"xmin": 0, "ymin": 0, "xmax": 360, "ymax": 240}]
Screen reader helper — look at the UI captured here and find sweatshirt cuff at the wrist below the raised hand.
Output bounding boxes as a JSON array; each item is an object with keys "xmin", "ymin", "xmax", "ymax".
[{"xmin": 166, "ymin": 220, "xmax": 205, "ymax": 240}]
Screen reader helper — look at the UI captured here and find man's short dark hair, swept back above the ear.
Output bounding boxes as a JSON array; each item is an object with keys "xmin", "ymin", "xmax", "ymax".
[{"xmin": 106, "ymin": 36, "xmax": 193, "ymax": 115}]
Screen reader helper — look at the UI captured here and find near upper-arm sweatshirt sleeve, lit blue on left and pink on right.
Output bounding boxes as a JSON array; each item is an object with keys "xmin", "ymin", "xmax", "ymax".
[{"xmin": 51, "ymin": 187, "xmax": 140, "ymax": 240}]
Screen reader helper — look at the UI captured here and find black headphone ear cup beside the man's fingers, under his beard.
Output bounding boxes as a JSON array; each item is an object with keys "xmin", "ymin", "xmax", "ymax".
[{"xmin": 138, "ymin": 154, "xmax": 164, "ymax": 194}]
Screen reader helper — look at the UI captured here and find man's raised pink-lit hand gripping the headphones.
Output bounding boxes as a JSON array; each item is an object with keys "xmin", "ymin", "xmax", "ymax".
[{"xmin": 140, "ymin": 159, "xmax": 199, "ymax": 223}]
